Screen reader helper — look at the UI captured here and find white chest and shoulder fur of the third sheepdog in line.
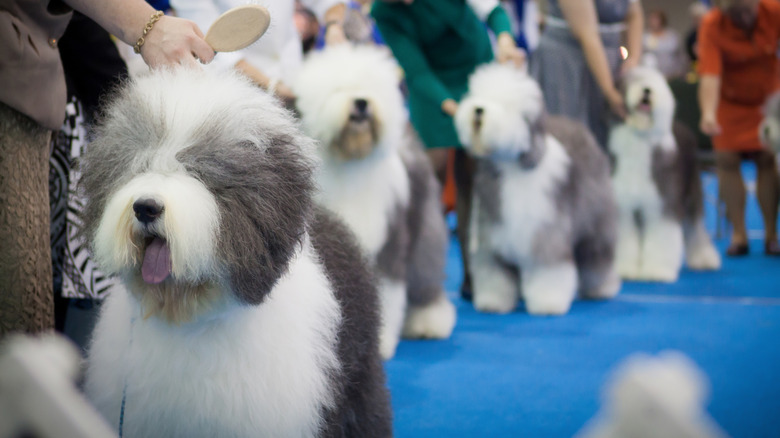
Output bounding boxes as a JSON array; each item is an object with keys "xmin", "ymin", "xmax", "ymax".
[{"xmin": 489, "ymin": 135, "xmax": 571, "ymax": 265}]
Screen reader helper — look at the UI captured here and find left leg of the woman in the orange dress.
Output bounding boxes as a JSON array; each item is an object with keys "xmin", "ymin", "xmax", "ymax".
[{"xmin": 715, "ymin": 151, "xmax": 747, "ymax": 255}]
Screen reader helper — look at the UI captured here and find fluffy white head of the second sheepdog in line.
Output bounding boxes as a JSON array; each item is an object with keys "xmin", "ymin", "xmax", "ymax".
[{"xmin": 294, "ymin": 44, "xmax": 406, "ymax": 161}]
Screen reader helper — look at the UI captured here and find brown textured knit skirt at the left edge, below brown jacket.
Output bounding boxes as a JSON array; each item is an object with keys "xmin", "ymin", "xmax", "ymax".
[{"xmin": 0, "ymin": 103, "xmax": 54, "ymax": 337}]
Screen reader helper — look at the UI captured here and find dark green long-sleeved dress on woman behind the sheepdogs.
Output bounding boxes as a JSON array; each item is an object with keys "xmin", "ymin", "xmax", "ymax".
[{"xmin": 371, "ymin": 0, "xmax": 511, "ymax": 148}]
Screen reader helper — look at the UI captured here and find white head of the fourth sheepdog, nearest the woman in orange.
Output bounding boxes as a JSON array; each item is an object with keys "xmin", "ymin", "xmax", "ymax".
[{"xmin": 624, "ymin": 67, "xmax": 675, "ymax": 133}]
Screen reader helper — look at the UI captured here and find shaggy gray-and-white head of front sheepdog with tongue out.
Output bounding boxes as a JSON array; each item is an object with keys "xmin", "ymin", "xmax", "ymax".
[{"xmin": 81, "ymin": 68, "xmax": 314, "ymax": 322}]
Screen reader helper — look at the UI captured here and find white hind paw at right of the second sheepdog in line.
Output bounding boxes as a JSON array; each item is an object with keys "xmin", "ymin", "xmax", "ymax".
[{"xmin": 403, "ymin": 293, "xmax": 455, "ymax": 339}]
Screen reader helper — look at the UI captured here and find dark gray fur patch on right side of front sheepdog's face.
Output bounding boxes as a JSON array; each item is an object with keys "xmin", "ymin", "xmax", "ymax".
[{"xmin": 177, "ymin": 135, "xmax": 314, "ymax": 304}]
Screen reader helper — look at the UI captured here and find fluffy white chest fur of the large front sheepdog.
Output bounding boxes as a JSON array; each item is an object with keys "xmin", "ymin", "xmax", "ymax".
[{"xmin": 86, "ymin": 239, "xmax": 341, "ymax": 437}]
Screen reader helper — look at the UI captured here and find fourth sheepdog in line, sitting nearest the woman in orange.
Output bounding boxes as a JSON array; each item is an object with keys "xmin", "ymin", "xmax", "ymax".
[{"xmin": 609, "ymin": 67, "xmax": 720, "ymax": 282}]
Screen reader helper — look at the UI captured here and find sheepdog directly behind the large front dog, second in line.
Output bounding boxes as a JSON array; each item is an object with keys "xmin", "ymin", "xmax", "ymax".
[{"xmin": 295, "ymin": 45, "xmax": 455, "ymax": 358}]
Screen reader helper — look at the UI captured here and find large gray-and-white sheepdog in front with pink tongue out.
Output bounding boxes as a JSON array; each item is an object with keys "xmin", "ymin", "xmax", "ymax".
[{"xmin": 82, "ymin": 69, "xmax": 391, "ymax": 437}]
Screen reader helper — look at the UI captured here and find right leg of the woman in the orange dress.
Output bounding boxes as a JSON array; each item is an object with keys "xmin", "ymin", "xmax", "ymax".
[{"xmin": 754, "ymin": 151, "xmax": 780, "ymax": 255}]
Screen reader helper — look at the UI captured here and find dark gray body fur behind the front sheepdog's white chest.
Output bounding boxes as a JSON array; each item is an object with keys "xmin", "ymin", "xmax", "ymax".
[{"xmin": 309, "ymin": 208, "xmax": 392, "ymax": 438}]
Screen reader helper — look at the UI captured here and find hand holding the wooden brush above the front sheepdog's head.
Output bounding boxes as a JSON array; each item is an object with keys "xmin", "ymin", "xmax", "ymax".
[{"xmin": 141, "ymin": 15, "xmax": 214, "ymax": 68}]
